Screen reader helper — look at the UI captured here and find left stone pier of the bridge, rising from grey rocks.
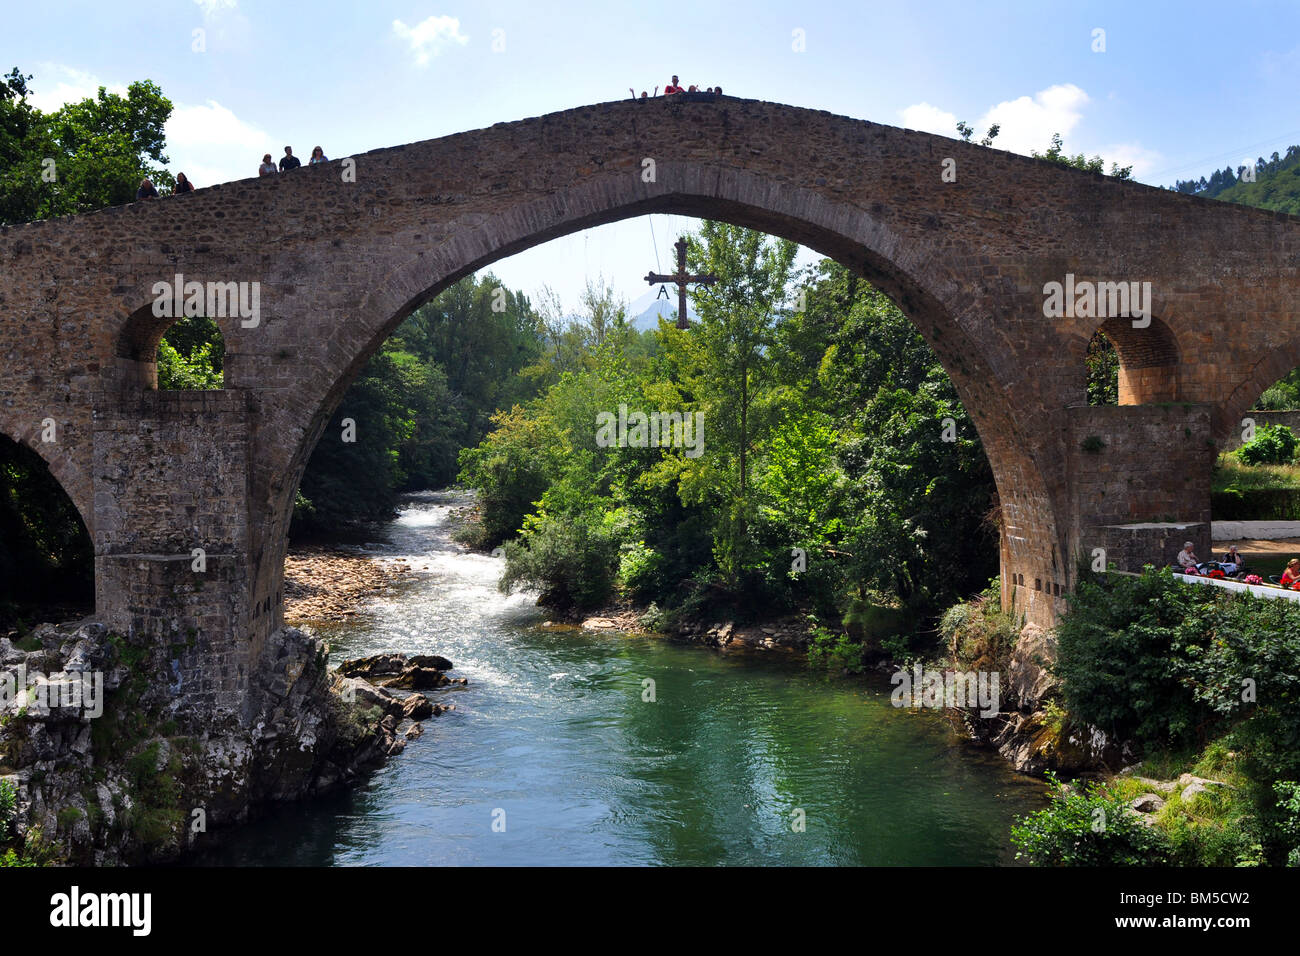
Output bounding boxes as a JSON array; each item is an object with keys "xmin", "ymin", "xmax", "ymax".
[{"xmin": 94, "ymin": 390, "xmax": 261, "ymax": 722}]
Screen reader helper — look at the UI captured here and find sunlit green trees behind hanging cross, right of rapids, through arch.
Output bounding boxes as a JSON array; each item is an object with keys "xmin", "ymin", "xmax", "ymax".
[{"xmin": 462, "ymin": 221, "xmax": 996, "ymax": 636}]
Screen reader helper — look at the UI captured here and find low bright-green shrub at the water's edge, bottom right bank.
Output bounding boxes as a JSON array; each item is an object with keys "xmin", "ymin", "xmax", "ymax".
[{"xmin": 1011, "ymin": 774, "xmax": 1173, "ymax": 866}]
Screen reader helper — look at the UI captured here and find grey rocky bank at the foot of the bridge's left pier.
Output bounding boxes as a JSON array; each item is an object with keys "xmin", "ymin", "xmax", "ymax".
[{"xmin": 0, "ymin": 613, "xmax": 464, "ymax": 865}]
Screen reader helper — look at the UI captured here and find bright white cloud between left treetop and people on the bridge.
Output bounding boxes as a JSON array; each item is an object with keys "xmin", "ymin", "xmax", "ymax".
[{"xmin": 165, "ymin": 100, "xmax": 274, "ymax": 187}]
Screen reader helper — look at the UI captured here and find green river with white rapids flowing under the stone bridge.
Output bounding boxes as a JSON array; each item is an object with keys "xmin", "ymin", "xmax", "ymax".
[{"xmin": 194, "ymin": 492, "xmax": 1047, "ymax": 866}]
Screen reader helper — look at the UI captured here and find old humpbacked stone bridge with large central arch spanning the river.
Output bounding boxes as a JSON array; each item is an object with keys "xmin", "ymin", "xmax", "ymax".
[{"xmin": 0, "ymin": 98, "xmax": 1300, "ymax": 710}]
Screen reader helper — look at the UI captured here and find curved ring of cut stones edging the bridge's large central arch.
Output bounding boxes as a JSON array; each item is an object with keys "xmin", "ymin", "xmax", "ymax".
[{"xmin": 266, "ymin": 174, "xmax": 1073, "ymax": 629}]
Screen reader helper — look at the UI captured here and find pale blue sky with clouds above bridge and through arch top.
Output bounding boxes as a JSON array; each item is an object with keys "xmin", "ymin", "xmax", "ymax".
[{"xmin": 0, "ymin": 0, "xmax": 1300, "ymax": 314}]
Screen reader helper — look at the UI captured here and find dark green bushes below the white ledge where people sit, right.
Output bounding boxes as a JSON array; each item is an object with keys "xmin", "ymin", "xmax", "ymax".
[{"xmin": 1056, "ymin": 570, "xmax": 1300, "ymax": 862}]
